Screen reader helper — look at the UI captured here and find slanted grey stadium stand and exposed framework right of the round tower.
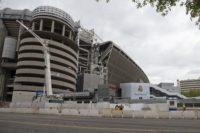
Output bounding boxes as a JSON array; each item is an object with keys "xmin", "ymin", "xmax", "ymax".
[{"xmin": 77, "ymin": 30, "xmax": 149, "ymax": 92}]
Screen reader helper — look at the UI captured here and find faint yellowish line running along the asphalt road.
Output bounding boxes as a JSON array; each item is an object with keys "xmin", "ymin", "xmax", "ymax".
[{"xmin": 0, "ymin": 120, "xmax": 199, "ymax": 133}]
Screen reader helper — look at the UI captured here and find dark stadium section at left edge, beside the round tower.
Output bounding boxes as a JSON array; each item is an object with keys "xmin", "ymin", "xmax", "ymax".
[{"xmin": 0, "ymin": 8, "xmax": 32, "ymax": 101}]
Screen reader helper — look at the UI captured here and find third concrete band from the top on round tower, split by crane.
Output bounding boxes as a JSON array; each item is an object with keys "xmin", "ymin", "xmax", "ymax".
[{"xmin": 18, "ymin": 53, "xmax": 77, "ymax": 71}]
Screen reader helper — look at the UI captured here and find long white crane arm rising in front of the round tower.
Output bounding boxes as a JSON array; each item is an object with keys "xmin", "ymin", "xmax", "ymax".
[{"xmin": 16, "ymin": 20, "xmax": 53, "ymax": 96}]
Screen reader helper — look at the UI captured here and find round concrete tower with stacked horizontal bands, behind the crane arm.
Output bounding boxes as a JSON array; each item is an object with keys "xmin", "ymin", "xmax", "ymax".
[{"xmin": 14, "ymin": 6, "xmax": 78, "ymax": 101}]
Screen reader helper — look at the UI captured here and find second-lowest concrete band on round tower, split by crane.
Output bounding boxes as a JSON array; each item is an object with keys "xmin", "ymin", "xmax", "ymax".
[{"xmin": 15, "ymin": 77, "xmax": 75, "ymax": 90}]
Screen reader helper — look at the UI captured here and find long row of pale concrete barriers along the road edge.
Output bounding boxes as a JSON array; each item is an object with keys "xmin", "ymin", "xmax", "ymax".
[{"xmin": 0, "ymin": 108, "xmax": 200, "ymax": 119}]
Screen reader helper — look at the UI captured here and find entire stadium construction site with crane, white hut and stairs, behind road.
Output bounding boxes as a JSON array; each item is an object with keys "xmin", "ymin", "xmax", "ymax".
[{"xmin": 0, "ymin": 6, "xmax": 200, "ymax": 118}]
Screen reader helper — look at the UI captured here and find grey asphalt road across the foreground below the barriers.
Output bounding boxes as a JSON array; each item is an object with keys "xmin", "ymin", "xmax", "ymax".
[{"xmin": 0, "ymin": 113, "xmax": 200, "ymax": 133}]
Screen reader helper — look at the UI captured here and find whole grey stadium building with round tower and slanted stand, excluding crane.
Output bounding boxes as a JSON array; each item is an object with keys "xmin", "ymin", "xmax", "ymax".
[{"xmin": 0, "ymin": 6, "xmax": 149, "ymax": 102}]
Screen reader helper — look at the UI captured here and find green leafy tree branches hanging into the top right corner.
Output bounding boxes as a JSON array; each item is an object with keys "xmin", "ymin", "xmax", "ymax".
[{"xmin": 96, "ymin": 0, "xmax": 200, "ymax": 28}]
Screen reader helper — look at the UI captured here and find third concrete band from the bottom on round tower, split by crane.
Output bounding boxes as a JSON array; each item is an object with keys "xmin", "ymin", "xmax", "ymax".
[{"xmin": 16, "ymin": 68, "xmax": 76, "ymax": 84}]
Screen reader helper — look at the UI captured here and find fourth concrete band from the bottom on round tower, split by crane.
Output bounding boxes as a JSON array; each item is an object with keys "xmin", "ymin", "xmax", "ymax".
[{"xmin": 17, "ymin": 61, "xmax": 76, "ymax": 78}]
